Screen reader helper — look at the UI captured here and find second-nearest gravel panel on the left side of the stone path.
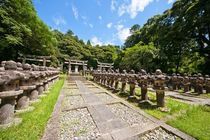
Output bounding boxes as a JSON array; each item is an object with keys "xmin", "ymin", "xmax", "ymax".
[{"xmin": 63, "ymin": 96, "xmax": 84, "ymax": 108}]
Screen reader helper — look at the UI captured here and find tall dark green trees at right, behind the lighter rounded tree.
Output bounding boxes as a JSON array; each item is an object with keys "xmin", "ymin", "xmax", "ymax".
[{"xmin": 124, "ymin": 0, "xmax": 210, "ymax": 73}]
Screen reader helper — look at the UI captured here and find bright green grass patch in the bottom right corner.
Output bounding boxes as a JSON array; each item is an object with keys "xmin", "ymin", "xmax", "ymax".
[{"xmin": 167, "ymin": 106, "xmax": 210, "ymax": 140}]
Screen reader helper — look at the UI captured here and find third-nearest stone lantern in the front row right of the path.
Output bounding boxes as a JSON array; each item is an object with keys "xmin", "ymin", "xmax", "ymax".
[{"xmin": 128, "ymin": 70, "xmax": 137, "ymax": 99}]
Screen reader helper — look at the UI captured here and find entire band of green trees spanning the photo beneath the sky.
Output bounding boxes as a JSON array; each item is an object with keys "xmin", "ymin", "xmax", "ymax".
[{"xmin": 0, "ymin": 0, "xmax": 210, "ymax": 74}]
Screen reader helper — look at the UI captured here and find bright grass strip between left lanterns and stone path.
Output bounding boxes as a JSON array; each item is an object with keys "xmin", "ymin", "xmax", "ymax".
[{"xmin": 0, "ymin": 75, "xmax": 65, "ymax": 140}]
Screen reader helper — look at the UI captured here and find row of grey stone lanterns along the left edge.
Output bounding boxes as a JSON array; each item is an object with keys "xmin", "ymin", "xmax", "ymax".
[{"xmin": 0, "ymin": 61, "xmax": 59, "ymax": 126}]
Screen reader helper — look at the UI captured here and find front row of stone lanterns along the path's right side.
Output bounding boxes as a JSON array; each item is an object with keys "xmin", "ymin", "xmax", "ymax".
[{"xmin": 93, "ymin": 69, "xmax": 166, "ymax": 107}]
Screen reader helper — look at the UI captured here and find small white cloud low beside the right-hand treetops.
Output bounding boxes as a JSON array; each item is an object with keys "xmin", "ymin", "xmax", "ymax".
[{"xmin": 115, "ymin": 24, "xmax": 130, "ymax": 42}]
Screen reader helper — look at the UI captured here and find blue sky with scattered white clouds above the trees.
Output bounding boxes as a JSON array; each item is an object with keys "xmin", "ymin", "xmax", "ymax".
[{"xmin": 33, "ymin": 0, "xmax": 175, "ymax": 45}]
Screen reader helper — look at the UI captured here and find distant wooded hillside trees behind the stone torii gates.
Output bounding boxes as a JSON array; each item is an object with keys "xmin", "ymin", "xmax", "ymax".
[{"xmin": 54, "ymin": 30, "xmax": 120, "ymax": 68}]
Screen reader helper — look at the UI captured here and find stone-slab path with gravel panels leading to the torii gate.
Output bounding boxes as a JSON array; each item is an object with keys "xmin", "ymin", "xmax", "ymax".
[{"xmin": 42, "ymin": 76, "xmax": 193, "ymax": 140}]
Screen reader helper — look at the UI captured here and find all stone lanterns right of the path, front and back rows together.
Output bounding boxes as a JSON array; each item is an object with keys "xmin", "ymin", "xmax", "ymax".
[{"xmin": 93, "ymin": 69, "xmax": 210, "ymax": 106}]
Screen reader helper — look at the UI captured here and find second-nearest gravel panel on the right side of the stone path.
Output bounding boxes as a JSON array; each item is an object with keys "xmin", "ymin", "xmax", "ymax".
[{"xmin": 108, "ymin": 103, "xmax": 152, "ymax": 127}]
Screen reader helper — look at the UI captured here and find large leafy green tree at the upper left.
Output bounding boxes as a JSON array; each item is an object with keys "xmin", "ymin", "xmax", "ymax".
[{"xmin": 0, "ymin": 0, "xmax": 57, "ymax": 60}]
